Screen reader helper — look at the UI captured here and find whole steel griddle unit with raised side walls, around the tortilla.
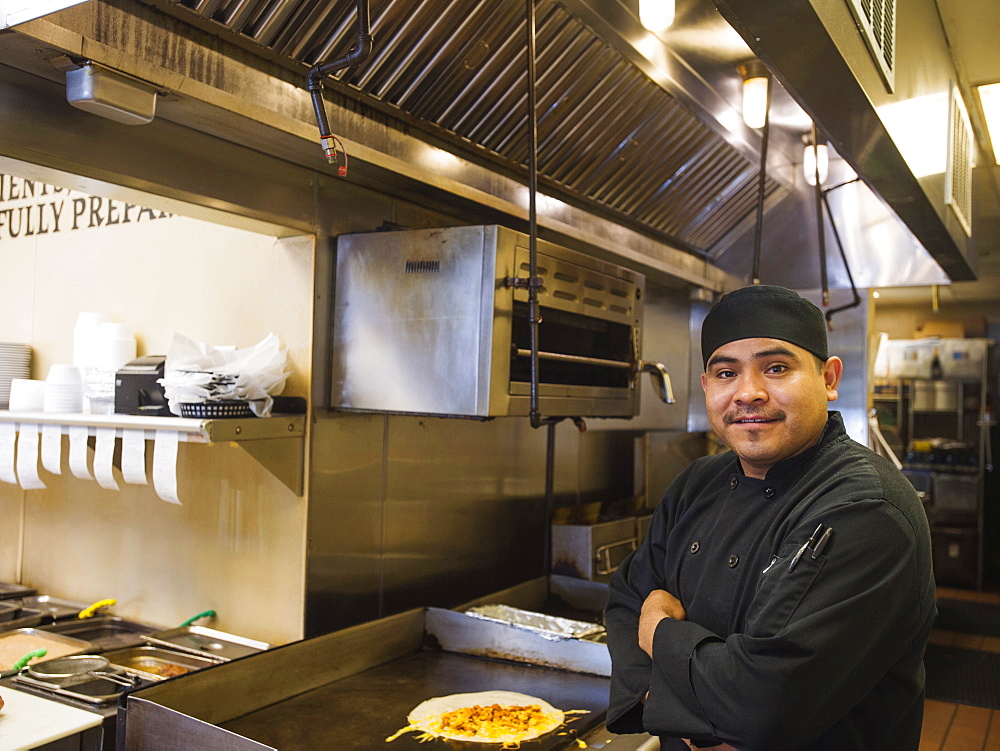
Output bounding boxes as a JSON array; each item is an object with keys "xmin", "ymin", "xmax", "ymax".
[{"xmin": 119, "ymin": 581, "xmax": 656, "ymax": 751}]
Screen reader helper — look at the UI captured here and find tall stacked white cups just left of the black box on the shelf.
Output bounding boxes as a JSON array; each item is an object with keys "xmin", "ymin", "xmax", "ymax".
[{"xmin": 73, "ymin": 313, "xmax": 136, "ymax": 415}]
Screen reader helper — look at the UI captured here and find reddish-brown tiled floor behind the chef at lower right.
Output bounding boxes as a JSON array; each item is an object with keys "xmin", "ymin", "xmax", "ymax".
[{"xmin": 920, "ymin": 588, "xmax": 1000, "ymax": 751}]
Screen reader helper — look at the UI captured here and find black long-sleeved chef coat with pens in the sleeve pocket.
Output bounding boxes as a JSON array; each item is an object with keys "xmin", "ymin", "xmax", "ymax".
[{"xmin": 606, "ymin": 412, "xmax": 936, "ymax": 751}]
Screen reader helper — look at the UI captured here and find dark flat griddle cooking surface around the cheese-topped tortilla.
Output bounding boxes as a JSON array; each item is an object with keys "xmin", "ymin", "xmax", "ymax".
[{"xmin": 220, "ymin": 651, "xmax": 610, "ymax": 751}]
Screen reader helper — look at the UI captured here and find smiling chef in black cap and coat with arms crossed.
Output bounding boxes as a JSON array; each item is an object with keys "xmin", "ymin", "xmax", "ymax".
[{"xmin": 606, "ymin": 286, "xmax": 936, "ymax": 751}]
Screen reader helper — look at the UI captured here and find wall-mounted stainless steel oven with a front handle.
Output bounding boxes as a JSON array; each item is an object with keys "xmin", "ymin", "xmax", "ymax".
[{"xmin": 331, "ymin": 225, "xmax": 670, "ymax": 417}]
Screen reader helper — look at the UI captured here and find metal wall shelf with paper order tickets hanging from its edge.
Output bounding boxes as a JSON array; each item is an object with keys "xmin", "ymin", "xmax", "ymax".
[{"xmin": 0, "ymin": 410, "xmax": 306, "ymax": 496}]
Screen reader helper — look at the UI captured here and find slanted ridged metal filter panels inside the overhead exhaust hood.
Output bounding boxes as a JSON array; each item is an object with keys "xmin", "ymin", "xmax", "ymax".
[{"xmin": 146, "ymin": 0, "xmax": 789, "ymax": 257}]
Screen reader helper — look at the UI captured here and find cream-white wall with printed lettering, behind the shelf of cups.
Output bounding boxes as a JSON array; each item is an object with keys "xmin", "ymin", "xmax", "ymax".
[{"xmin": 0, "ymin": 176, "xmax": 315, "ymax": 643}]
